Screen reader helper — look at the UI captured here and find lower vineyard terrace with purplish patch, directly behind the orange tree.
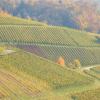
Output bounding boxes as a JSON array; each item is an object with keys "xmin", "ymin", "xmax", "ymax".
[{"xmin": 17, "ymin": 45, "xmax": 100, "ymax": 66}]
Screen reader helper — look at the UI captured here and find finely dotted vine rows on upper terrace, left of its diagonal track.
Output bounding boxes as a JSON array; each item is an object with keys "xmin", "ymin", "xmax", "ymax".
[{"xmin": 0, "ymin": 26, "xmax": 75, "ymax": 45}]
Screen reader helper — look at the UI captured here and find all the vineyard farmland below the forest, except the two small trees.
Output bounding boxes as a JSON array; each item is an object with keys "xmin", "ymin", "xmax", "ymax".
[{"xmin": 0, "ymin": 16, "xmax": 100, "ymax": 100}]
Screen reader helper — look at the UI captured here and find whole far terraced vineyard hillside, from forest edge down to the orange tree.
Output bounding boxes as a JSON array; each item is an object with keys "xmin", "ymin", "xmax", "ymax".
[{"xmin": 0, "ymin": 17, "xmax": 100, "ymax": 66}]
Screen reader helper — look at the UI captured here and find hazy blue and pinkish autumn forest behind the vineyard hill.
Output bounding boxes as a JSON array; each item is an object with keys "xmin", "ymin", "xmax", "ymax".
[{"xmin": 0, "ymin": 0, "xmax": 100, "ymax": 33}]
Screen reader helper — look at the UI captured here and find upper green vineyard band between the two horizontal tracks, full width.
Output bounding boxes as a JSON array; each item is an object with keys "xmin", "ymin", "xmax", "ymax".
[{"xmin": 0, "ymin": 25, "xmax": 100, "ymax": 46}]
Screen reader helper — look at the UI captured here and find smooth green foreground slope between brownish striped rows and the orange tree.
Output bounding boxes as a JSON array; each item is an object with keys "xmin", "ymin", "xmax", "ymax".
[{"xmin": 0, "ymin": 51, "xmax": 94, "ymax": 89}]
